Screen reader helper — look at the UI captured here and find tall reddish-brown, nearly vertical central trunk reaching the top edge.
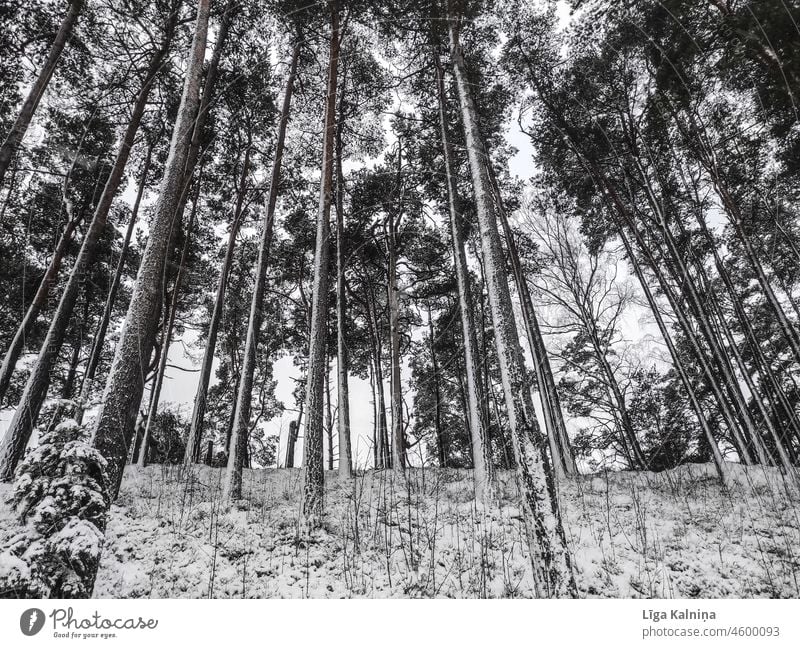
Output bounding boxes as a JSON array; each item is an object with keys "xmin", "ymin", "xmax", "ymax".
[{"xmin": 301, "ymin": 1, "xmax": 341, "ymax": 531}]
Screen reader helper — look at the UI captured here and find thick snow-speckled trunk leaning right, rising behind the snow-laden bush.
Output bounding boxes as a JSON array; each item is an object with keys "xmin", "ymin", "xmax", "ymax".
[{"xmin": 93, "ymin": 0, "xmax": 210, "ymax": 497}]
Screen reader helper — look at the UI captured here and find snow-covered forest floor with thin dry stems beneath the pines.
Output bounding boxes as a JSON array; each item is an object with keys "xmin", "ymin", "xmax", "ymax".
[{"xmin": 0, "ymin": 465, "xmax": 800, "ymax": 598}]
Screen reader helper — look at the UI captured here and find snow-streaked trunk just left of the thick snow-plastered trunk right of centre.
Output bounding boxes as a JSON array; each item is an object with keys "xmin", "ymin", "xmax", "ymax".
[{"xmin": 431, "ymin": 50, "xmax": 494, "ymax": 501}]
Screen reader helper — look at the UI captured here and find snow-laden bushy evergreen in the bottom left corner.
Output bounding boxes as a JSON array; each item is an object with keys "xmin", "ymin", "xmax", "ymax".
[{"xmin": 0, "ymin": 420, "xmax": 110, "ymax": 598}]
